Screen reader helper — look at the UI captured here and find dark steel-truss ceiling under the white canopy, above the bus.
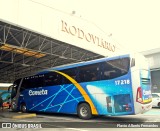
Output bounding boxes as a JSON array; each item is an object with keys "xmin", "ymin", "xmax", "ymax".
[{"xmin": 0, "ymin": 21, "xmax": 103, "ymax": 83}]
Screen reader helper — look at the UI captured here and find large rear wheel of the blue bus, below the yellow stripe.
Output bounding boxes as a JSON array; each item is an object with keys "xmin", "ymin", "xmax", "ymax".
[{"xmin": 77, "ymin": 103, "xmax": 92, "ymax": 120}]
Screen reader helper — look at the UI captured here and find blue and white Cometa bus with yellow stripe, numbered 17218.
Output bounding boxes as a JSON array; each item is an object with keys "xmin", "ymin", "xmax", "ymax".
[{"xmin": 8, "ymin": 54, "xmax": 152, "ymax": 119}]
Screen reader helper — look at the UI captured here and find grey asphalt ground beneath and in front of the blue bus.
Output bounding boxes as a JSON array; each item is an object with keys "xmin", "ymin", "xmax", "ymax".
[{"xmin": 0, "ymin": 108, "xmax": 160, "ymax": 131}]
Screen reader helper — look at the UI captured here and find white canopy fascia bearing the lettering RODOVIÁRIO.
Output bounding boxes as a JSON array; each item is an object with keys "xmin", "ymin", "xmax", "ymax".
[{"xmin": 0, "ymin": 0, "xmax": 124, "ymax": 56}]
